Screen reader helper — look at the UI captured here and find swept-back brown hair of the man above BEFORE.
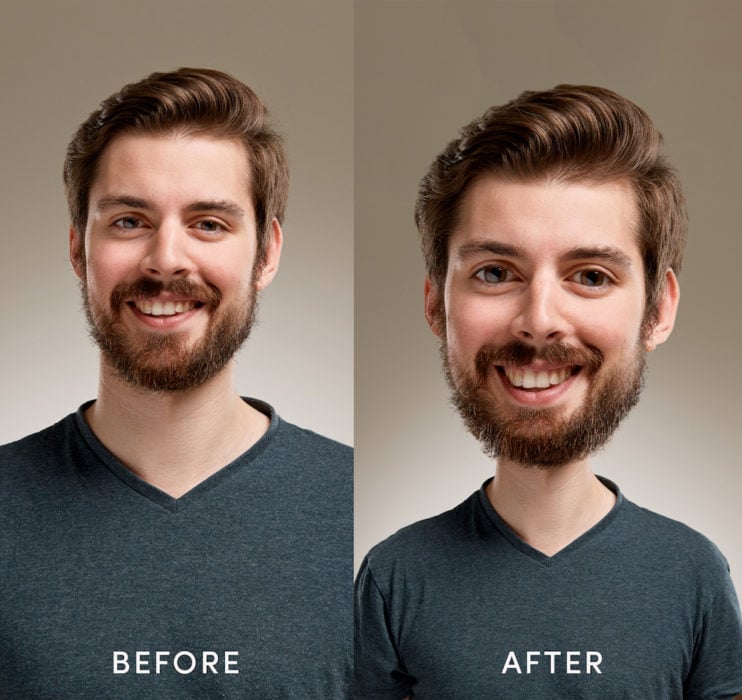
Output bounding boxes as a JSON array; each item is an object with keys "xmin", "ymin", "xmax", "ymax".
[{"xmin": 64, "ymin": 68, "xmax": 288, "ymax": 262}]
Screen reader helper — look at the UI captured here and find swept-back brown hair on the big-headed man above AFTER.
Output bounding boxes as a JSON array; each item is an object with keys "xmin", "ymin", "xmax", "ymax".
[{"xmin": 415, "ymin": 85, "xmax": 687, "ymax": 323}]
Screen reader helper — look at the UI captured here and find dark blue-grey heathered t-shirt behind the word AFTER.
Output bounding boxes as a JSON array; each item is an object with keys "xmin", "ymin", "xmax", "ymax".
[{"xmin": 355, "ymin": 481, "xmax": 742, "ymax": 700}]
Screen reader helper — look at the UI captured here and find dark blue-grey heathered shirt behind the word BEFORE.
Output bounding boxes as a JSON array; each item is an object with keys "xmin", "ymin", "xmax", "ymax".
[{"xmin": 0, "ymin": 400, "xmax": 352, "ymax": 700}]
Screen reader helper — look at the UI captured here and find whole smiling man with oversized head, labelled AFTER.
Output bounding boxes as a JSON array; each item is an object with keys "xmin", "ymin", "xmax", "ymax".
[{"xmin": 355, "ymin": 85, "xmax": 742, "ymax": 700}]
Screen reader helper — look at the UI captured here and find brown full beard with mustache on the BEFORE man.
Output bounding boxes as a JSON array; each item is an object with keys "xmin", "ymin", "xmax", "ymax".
[{"xmin": 81, "ymin": 271, "xmax": 257, "ymax": 392}]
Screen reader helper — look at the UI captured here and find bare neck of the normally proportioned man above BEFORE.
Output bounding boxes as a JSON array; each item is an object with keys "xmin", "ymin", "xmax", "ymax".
[{"xmin": 85, "ymin": 362, "xmax": 269, "ymax": 498}]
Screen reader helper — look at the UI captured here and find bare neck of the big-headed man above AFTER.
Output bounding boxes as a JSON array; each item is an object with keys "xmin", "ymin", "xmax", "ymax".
[{"xmin": 487, "ymin": 460, "xmax": 616, "ymax": 556}]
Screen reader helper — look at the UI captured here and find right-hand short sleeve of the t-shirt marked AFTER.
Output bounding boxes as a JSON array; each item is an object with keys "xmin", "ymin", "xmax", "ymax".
[{"xmin": 685, "ymin": 569, "xmax": 742, "ymax": 700}]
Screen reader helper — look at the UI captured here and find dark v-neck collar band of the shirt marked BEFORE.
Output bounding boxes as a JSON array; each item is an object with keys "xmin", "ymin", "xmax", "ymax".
[{"xmin": 74, "ymin": 397, "xmax": 281, "ymax": 513}]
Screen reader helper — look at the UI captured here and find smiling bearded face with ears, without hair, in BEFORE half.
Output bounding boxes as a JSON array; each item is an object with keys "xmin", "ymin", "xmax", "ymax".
[{"xmin": 71, "ymin": 134, "xmax": 281, "ymax": 391}]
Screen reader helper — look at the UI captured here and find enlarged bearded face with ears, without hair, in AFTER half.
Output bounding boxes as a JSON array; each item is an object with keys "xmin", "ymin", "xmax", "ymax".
[{"xmin": 426, "ymin": 176, "xmax": 677, "ymax": 467}]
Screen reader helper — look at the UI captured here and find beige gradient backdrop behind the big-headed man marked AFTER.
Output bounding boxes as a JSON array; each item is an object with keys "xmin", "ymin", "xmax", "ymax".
[{"xmin": 355, "ymin": 0, "xmax": 742, "ymax": 591}]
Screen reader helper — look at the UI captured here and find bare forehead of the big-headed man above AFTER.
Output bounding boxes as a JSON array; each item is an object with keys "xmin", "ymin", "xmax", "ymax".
[{"xmin": 448, "ymin": 175, "xmax": 642, "ymax": 267}]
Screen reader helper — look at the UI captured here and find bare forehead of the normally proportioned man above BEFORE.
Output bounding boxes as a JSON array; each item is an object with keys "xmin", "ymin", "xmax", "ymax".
[{"xmin": 90, "ymin": 132, "xmax": 250, "ymax": 201}]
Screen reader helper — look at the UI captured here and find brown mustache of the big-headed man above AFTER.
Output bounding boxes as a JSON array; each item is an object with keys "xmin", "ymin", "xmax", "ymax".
[{"xmin": 475, "ymin": 340, "xmax": 603, "ymax": 379}]
